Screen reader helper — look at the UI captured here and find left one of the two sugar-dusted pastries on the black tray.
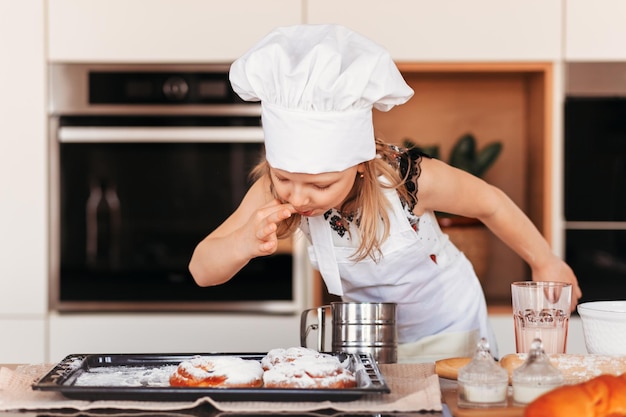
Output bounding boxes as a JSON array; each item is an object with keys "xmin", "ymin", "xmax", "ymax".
[{"xmin": 170, "ymin": 356, "xmax": 263, "ymax": 388}]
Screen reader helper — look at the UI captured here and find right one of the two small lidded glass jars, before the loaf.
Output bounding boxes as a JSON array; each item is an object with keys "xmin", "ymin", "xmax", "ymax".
[{"xmin": 512, "ymin": 338, "xmax": 564, "ymax": 405}]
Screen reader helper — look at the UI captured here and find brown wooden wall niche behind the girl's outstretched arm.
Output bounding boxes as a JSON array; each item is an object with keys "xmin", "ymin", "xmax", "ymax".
[{"xmin": 374, "ymin": 63, "xmax": 553, "ymax": 299}]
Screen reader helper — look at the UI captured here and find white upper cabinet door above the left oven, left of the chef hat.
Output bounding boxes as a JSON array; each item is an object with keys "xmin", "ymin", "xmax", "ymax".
[{"xmin": 48, "ymin": 0, "xmax": 302, "ymax": 63}]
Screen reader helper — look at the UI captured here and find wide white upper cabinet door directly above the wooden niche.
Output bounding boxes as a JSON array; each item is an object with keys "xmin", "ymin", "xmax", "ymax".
[{"xmin": 306, "ymin": 0, "xmax": 562, "ymax": 62}]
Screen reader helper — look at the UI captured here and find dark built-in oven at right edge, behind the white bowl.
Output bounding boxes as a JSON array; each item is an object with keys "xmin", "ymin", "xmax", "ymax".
[{"xmin": 564, "ymin": 62, "xmax": 626, "ymax": 301}]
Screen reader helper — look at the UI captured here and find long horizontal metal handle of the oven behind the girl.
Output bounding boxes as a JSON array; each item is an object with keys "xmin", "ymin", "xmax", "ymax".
[{"xmin": 57, "ymin": 126, "xmax": 263, "ymax": 143}]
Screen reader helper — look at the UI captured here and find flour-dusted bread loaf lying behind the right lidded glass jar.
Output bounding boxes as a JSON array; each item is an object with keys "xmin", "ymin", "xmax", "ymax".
[{"xmin": 500, "ymin": 353, "xmax": 626, "ymax": 385}]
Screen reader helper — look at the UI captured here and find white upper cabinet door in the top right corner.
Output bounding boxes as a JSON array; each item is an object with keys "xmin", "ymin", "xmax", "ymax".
[{"xmin": 565, "ymin": 0, "xmax": 626, "ymax": 61}]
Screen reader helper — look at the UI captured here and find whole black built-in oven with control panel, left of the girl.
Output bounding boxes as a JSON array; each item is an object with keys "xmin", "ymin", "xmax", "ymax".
[{"xmin": 49, "ymin": 64, "xmax": 311, "ymax": 313}]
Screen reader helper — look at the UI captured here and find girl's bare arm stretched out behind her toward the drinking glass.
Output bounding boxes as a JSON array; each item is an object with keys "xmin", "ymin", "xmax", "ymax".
[{"xmin": 416, "ymin": 158, "xmax": 582, "ymax": 310}]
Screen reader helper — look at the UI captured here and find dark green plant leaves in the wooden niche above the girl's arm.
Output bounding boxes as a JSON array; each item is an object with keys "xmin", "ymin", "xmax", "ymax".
[{"xmin": 403, "ymin": 133, "xmax": 502, "ymax": 178}]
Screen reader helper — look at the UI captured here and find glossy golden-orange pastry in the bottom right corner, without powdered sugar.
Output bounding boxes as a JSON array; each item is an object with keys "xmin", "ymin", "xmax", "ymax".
[{"xmin": 524, "ymin": 374, "xmax": 626, "ymax": 417}]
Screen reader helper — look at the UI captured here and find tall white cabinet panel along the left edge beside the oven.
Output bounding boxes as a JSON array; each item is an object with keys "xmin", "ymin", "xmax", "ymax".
[{"xmin": 0, "ymin": 0, "xmax": 48, "ymax": 316}]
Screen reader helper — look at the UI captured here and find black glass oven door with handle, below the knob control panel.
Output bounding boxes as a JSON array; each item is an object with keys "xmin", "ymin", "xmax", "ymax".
[{"xmin": 50, "ymin": 116, "xmax": 306, "ymax": 313}]
